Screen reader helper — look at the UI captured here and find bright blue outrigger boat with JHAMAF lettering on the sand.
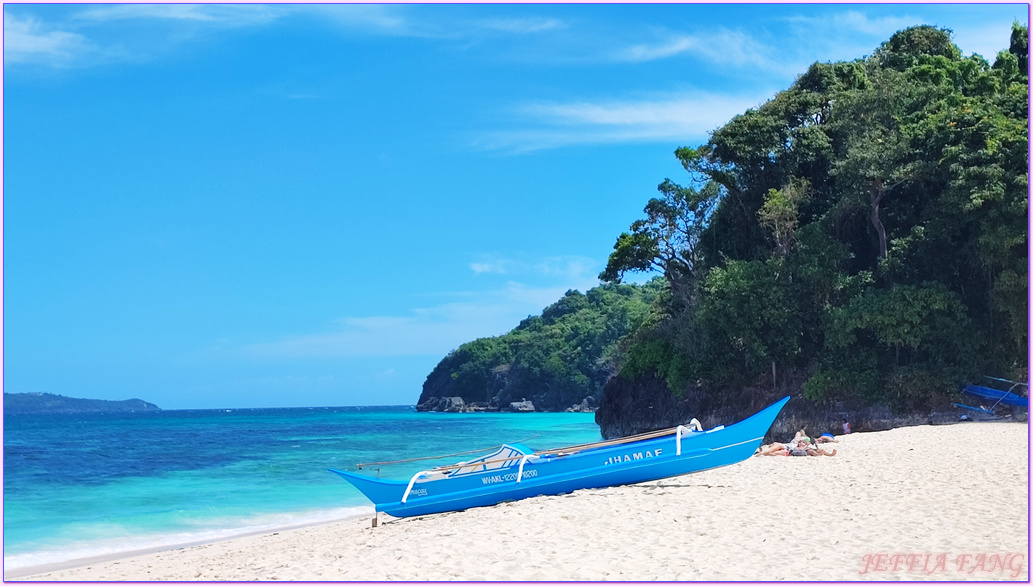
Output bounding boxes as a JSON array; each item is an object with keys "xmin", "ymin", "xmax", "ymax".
[{"xmin": 330, "ymin": 397, "xmax": 789, "ymax": 517}]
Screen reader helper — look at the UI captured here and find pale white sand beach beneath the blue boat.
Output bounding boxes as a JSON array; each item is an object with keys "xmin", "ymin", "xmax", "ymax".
[{"xmin": 7, "ymin": 423, "xmax": 1029, "ymax": 581}]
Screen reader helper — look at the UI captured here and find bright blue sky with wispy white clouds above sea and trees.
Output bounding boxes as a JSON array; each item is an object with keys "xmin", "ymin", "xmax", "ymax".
[{"xmin": 3, "ymin": 4, "xmax": 1029, "ymax": 408}]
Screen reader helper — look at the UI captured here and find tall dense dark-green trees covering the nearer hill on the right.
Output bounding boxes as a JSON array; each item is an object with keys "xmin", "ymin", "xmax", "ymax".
[{"xmin": 600, "ymin": 25, "xmax": 1029, "ymax": 409}]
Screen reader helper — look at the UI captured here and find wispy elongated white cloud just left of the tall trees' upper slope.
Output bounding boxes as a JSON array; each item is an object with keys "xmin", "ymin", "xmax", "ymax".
[{"xmin": 475, "ymin": 91, "xmax": 774, "ymax": 153}]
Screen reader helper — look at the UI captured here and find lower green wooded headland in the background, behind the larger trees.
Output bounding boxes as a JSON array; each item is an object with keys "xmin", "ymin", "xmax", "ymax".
[{"xmin": 418, "ymin": 279, "xmax": 663, "ymax": 410}]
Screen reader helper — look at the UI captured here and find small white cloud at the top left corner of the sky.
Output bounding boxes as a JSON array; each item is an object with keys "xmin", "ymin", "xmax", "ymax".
[{"xmin": 3, "ymin": 10, "xmax": 93, "ymax": 65}]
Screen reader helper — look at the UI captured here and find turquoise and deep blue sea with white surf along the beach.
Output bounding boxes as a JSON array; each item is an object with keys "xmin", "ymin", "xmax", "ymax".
[{"xmin": 3, "ymin": 407, "xmax": 600, "ymax": 570}]
